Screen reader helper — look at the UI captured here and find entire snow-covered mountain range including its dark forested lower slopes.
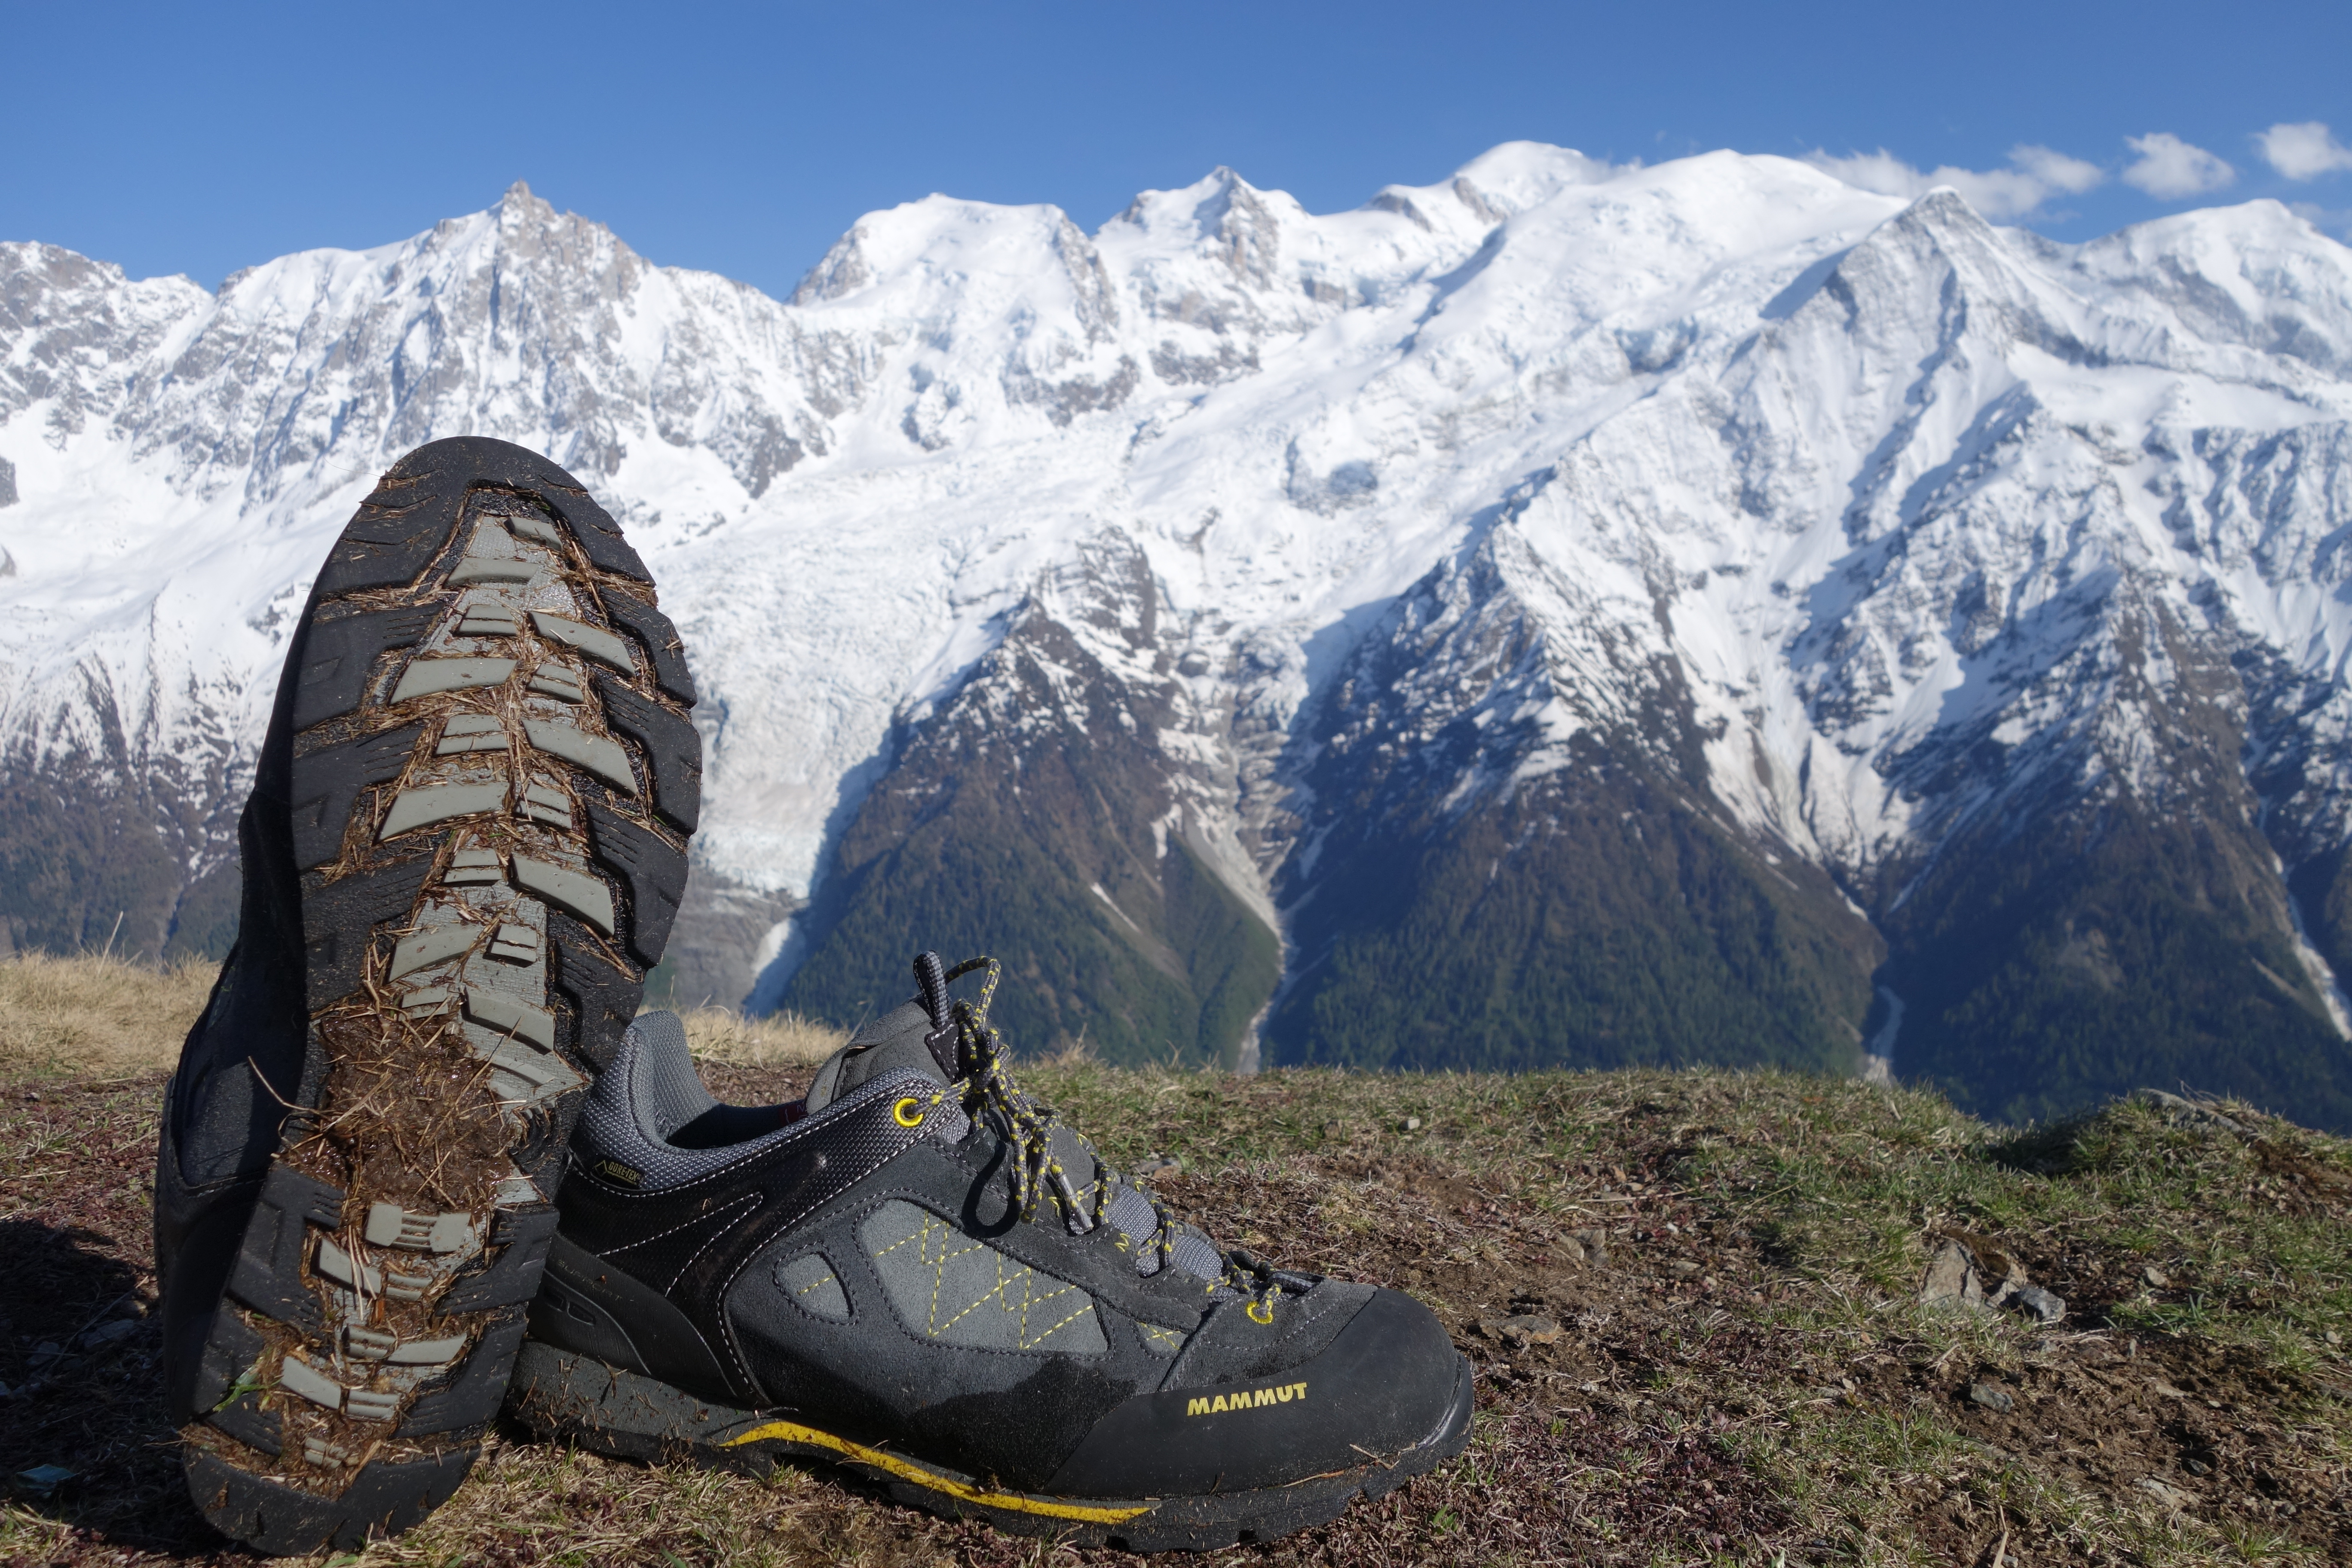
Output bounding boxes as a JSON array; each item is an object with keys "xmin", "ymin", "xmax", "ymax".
[{"xmin": 0, "ymin": 144, "xmax": 2352, "ymax": 1124}]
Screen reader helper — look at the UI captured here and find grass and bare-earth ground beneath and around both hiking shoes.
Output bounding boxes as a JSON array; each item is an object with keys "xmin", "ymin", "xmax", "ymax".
[{"xmin": 0, "ymin": 949, "xmax": 2352, "ymax": 1566}]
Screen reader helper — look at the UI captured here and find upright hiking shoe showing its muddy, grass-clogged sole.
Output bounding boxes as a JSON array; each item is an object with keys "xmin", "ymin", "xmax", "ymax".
[{"xmin": 155, "ymin": 437, "xmax": 701, "ymax": 1552}]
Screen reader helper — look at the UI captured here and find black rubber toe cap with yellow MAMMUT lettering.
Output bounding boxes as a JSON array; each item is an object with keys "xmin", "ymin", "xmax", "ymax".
[{"xmin": 1044, "ymin": 1291, "xmax": 1463, "ymax": 1498}]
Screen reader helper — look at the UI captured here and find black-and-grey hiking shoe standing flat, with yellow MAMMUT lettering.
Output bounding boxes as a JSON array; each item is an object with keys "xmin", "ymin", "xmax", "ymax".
[{"xmin": 508, "ymin": 955, "xmax": 1472, "ymax": 1552}]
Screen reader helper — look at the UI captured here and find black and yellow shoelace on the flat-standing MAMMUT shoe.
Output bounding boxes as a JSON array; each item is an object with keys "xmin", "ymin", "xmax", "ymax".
[{"xmin": 924, "ymin": 957, "xmax": 1298, "ymax": 1321}]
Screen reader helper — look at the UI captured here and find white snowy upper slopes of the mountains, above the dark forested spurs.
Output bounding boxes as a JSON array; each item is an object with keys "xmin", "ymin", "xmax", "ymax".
[{"xmin": 0, "ymin": 144, "xmax": 2352, "ymax": 1114}]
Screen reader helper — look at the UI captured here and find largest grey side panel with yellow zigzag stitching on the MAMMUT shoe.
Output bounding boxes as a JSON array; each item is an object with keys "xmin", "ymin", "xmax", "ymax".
[{"xmin": 858, "ymin": 1199, "xmax": 1108, "ymax": 1357}]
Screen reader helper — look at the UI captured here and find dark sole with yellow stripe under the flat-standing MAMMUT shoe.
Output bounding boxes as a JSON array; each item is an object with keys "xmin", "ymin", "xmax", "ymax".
[{"xmin": 508, "ymin": 1340, "xmax": 1475, "ymax": 1552}]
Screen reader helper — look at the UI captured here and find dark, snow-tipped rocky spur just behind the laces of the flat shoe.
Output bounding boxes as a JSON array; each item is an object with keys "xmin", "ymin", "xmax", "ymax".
[{"xmin": 783, "ymin": 536, "xmax": 1280, "ymax": 1067}]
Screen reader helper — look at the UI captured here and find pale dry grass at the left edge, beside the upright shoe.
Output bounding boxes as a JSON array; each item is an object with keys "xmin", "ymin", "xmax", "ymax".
[{"xmin": 0, "ymin": 952, "xmax": 219, "ymax": 1079}]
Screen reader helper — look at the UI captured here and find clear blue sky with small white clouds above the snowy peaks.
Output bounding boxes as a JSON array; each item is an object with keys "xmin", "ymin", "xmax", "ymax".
[{"xmin": 0, "ymin": 0, "xmax": 2352, "ymax": 294}]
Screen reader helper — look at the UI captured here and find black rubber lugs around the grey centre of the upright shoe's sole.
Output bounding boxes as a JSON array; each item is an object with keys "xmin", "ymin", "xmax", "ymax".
[{"xmin": 186, "ymin": 437, "xmax": 682, "ymax": 1554}]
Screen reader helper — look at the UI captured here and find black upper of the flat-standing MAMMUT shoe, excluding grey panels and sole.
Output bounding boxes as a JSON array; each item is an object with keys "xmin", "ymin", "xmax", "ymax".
[{"xmin": 532, "ymin": 1072, "xmax": 1458, "ymax": 1495}]
